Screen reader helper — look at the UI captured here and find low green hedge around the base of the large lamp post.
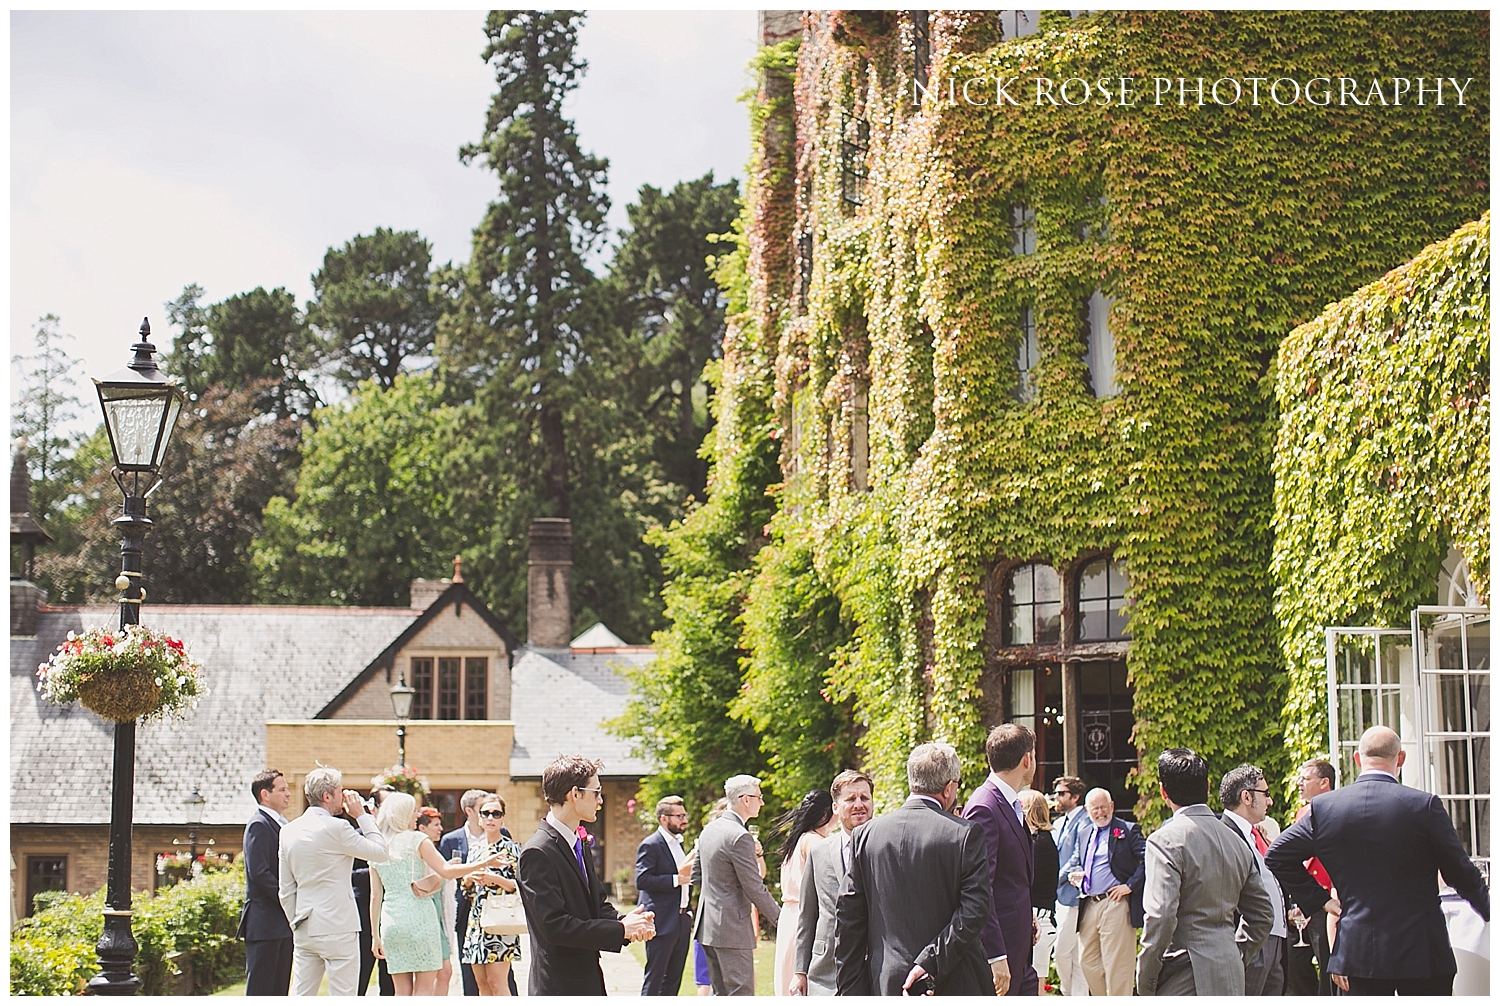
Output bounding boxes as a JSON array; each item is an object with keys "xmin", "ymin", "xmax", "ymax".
[{"xmin": 11, "ymin": 864, "xmax": 245, "ymax": 996}]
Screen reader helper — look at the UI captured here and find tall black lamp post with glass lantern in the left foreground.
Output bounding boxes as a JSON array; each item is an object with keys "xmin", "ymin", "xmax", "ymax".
[{"xmin": 89, "ymin": 319, "xmax": 185, "ymax": 996}]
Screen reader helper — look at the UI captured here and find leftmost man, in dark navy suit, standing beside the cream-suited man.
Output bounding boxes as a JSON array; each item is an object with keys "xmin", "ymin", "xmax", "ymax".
[{"xmin": 237, "ymin": 769, "xmax": 293, "ymax": 996}]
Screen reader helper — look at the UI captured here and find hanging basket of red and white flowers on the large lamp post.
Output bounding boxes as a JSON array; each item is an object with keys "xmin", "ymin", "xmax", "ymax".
[{"xmin": 36, "ymin": 625, "xmax": 209, "ymax": 723}]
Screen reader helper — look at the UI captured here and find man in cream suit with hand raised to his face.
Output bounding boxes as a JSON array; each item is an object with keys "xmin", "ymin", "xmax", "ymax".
[{"xmin": 279, "ymin": 768, "xmax": 390, "ymax": 996}]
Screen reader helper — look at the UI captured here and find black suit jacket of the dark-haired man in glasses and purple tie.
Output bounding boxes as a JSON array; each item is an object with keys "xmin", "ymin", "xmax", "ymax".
[{"xmin": 516, "ymin": 819, "xmax": 626, "ymax": 996}]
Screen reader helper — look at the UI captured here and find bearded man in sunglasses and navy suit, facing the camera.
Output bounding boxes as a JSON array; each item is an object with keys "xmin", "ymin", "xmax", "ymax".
[{"xmin": 636, "ymin": 796, "xmax": 693, "ymax": 996}]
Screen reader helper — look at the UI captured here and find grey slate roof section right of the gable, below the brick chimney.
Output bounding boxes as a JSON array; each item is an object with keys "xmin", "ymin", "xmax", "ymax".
[{"xmin": 510, "ymin": 650, "xmax": 656, "ymax": 778}]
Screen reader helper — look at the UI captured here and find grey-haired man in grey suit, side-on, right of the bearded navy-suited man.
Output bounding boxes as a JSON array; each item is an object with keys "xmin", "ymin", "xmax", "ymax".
[{"xmin": 693, "ymin": 775, "xmax": 782, "ymax": 996}]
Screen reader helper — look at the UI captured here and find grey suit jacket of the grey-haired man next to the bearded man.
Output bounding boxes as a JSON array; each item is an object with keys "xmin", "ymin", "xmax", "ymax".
[{"xmin": 693, "ymin": 811, "xmax": 782, "ymax": 951}]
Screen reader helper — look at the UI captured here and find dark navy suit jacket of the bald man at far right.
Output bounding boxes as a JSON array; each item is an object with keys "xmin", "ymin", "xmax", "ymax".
[{"xmin": 1266, "ymin": 774, "xmax": 1490, "ymax": 979}]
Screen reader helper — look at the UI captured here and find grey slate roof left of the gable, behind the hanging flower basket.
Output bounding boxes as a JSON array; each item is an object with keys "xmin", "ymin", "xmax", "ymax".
[{"xmin": 11, "ymin": 604, "xmax": 422, "ymax": 825}]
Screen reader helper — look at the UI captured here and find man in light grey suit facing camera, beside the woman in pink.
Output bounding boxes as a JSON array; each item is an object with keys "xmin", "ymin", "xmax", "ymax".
[{"xmin": 792, "ymin": 769, "xmax": 875, "ymax": 996}]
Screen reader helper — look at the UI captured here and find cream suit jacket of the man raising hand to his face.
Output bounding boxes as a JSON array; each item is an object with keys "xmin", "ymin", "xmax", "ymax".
[{"xmin": 279, "ymin": 807, "xmax": 390, "ymax": 939}]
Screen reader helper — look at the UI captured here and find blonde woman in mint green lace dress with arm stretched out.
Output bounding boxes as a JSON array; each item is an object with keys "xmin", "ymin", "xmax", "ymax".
[{"xmin": 371, "ymin": 793, "xmax": 500, "ymax": 996}]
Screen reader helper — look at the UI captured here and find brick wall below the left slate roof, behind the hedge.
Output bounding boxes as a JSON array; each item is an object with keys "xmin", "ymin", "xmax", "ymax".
[{"xmin": 11, "ymin": 825, "xmax": 245, "ymax": 915}]
